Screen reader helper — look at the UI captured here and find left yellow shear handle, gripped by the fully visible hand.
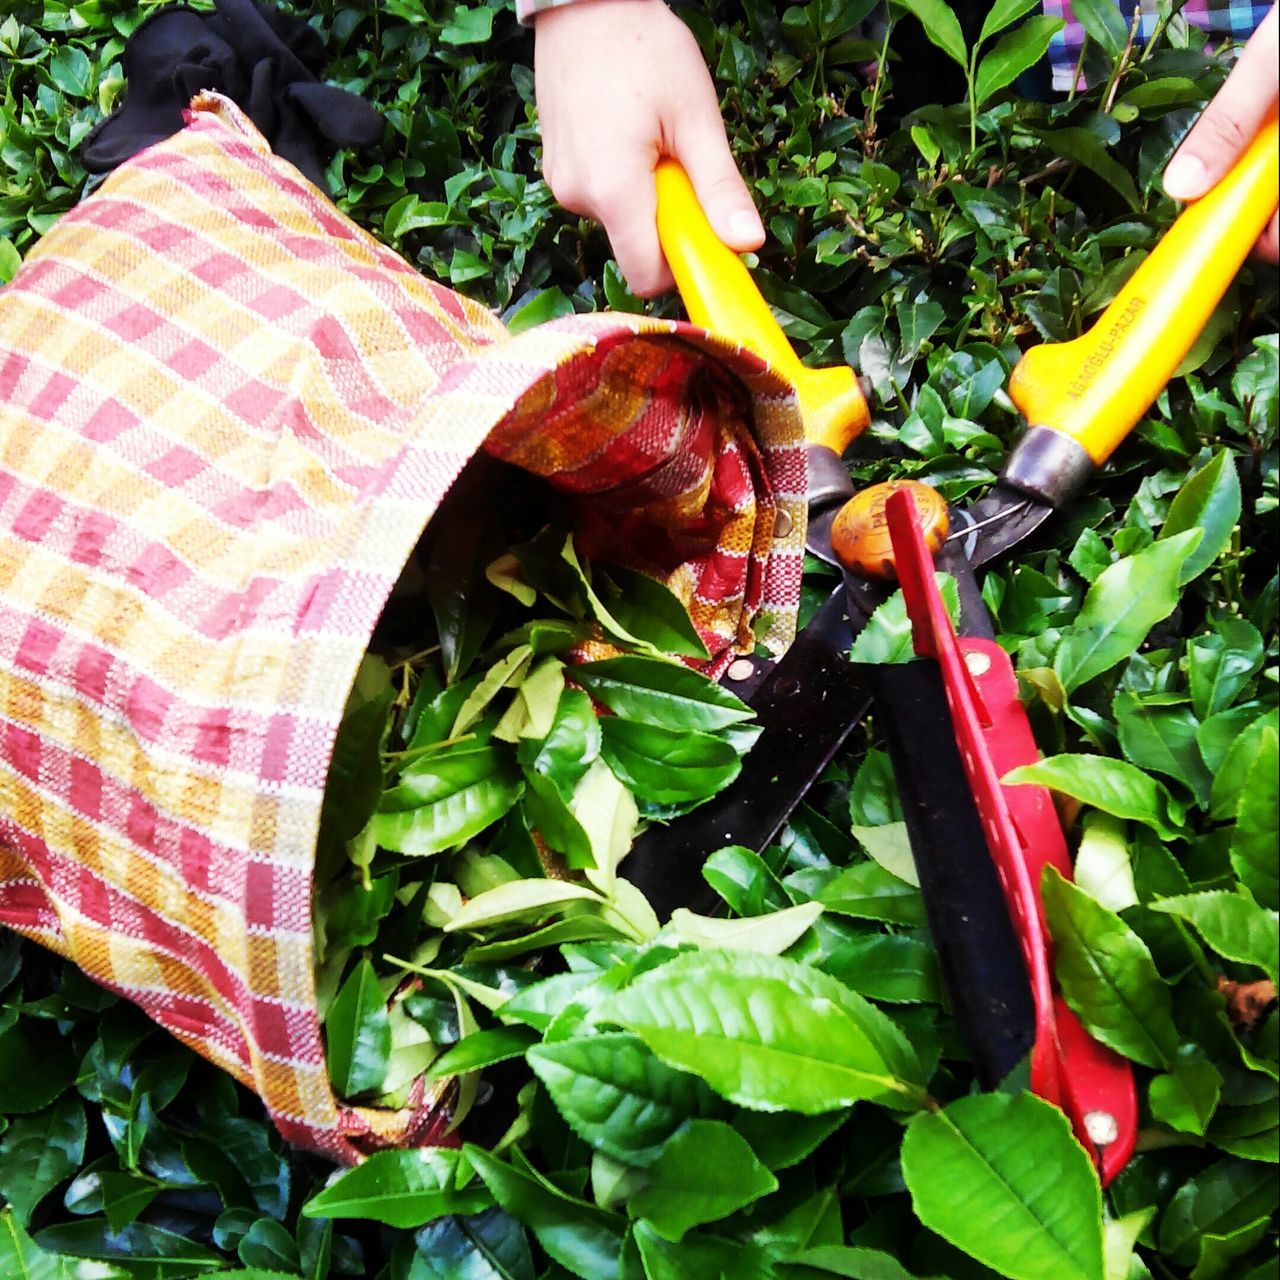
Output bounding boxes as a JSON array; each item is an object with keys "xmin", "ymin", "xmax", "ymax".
[{"xmin": 657, "ymin": 160, "xmax": 870, "ymax": 453}]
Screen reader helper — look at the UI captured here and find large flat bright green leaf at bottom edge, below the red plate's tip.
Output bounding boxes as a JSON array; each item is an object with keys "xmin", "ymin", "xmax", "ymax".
[{"xmin": 902, "ymin": 1093, "xmax": 1103, "ymax": 1280}]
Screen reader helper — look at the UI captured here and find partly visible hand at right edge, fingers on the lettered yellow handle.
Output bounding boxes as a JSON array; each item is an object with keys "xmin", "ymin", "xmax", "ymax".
[{"xmin": 1165, "ymin": 5, "xmax": 1280, "ymax": 262}]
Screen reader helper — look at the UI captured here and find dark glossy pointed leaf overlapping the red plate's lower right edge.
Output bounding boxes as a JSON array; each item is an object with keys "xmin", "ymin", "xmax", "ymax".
[{"xmin": 1041, "ymin": 867, "xmax": 1178, "ymax": 1069}]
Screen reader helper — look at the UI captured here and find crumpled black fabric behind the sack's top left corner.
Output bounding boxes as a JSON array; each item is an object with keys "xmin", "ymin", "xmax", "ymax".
[{"xmin": 81, "ymin": 0, "xmax": 383, "ymax": 188}]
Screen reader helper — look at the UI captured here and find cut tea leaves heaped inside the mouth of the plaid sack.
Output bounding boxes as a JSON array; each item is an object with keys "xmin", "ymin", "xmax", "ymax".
[{"xmin": 315, "ymin": 457, "xmax": 755, "ymax": 1124}]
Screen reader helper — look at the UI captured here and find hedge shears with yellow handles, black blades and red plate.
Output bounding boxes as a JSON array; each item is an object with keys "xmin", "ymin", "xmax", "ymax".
[{"xmin": 623, "ymin": 119, "xmax": 1277, "ymax": 1181}]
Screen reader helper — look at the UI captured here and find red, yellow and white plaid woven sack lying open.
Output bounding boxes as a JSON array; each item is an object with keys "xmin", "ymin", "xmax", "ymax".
[{"xmin": 0, "ymin": 95, "xmax": 806, "ymax": 1161}]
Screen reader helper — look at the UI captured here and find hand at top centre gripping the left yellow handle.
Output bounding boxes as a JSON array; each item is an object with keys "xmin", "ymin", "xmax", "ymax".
[{"xmin": 534, "ymin": 0, "xmax": 764, "ymax": 297}]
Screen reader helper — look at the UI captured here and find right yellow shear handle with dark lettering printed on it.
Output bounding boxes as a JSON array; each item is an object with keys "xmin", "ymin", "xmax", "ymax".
[{"xmin": 1009, "ymin": 119, "xmax": 1277, "ymax": 476}]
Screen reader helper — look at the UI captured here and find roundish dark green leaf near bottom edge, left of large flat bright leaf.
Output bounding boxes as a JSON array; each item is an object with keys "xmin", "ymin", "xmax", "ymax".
[{"xmin": 628, "ymin": 1120, "xmax": 778, "ymax": 1240}]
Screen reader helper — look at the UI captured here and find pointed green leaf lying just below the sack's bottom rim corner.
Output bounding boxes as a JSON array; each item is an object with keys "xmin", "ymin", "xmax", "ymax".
[{"xmin": 302, "ymin": 1147, "xmax": 493, "ymax": 1228}]
